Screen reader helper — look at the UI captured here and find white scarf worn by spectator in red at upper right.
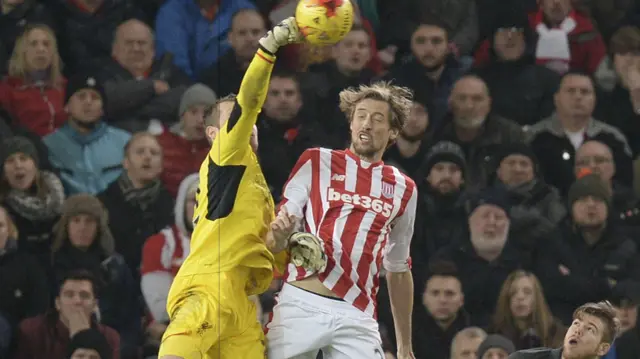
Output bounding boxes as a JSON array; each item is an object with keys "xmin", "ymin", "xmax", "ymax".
[{"xmin": 535, "ymin": 12, "xmax": 577, "ymax": 74}]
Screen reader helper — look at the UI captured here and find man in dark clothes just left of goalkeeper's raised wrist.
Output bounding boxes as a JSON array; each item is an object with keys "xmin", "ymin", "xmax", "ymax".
[{"xmin": 200, "ymin": 8, "xmax": 267, "ymax": 97}]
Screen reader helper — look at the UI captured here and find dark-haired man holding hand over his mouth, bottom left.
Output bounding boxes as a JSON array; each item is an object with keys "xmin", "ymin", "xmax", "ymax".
[{"xmin": 15, "ymin": 271, "xmax": 120, "ymax": 359}]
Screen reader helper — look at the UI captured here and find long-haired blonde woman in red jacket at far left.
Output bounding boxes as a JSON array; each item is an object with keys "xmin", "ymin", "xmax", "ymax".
[{"xmin": 0, "ymin": 25, "xmax": 67, "ymax": 136}]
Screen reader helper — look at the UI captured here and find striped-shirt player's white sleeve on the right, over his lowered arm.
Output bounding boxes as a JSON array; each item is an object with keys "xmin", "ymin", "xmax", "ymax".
[{"xmin": 383, "ymin": 185, "xmax": 418, "ymax": 272}]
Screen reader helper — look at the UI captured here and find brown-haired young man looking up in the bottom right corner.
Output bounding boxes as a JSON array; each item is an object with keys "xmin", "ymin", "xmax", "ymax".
[{"xmin": 509, "ymin": 302, "xmax": 616, "ymax": 359}]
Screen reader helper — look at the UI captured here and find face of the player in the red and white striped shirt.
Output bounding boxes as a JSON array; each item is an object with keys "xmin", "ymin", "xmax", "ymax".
[{"xmin": 350, "ymin": 99, "xmax": 398, "ymax": 162}]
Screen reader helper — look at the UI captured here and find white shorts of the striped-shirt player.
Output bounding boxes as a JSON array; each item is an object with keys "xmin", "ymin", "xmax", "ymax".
[{"xmin": 267, "ymin": 283, "xmax": 384, "ymax": 359}]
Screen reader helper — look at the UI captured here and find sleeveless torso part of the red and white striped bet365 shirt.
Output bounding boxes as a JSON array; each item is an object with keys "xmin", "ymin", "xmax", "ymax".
[{"xmin": 287, "ymin": 149, "xmax": 410, "ymax": 310}]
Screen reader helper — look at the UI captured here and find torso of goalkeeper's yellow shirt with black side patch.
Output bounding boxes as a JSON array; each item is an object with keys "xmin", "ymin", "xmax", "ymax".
[{"xmin": 181, "ymin": 147, "xmax": 274, "ymax": 274}]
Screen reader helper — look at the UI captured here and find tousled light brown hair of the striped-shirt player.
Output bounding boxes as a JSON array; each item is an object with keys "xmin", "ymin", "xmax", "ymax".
[{"xmin": 340, "ymin": 81, "xmax": 413, "ymax": 130}]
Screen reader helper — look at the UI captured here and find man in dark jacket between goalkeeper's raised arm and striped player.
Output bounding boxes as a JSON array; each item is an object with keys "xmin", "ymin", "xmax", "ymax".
[{"xmin": 258, "ymin": 70, "xmax": 326, "ymax": 203}]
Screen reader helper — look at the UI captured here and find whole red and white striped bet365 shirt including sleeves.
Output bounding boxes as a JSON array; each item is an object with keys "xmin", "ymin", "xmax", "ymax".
[{"xmin": 281, "ymin": 148, "xmax": 417, "ymax": 317}]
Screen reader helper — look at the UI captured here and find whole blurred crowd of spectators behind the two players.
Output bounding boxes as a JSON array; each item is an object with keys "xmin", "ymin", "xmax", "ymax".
[{"xmin": 0, "ymin": 0, "xmax": 640, "ymax": 359}]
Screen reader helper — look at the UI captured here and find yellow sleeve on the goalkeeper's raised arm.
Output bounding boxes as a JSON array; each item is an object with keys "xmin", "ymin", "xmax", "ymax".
[{"xmin": 209, "ymin": 48, "xmax": 275, "ymax": 166}]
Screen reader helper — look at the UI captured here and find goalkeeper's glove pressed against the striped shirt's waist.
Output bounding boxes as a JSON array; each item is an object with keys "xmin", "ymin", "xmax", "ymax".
[{"xmin": 289, "ymin": 232, "xmax": 327, "ymax": 272}]
